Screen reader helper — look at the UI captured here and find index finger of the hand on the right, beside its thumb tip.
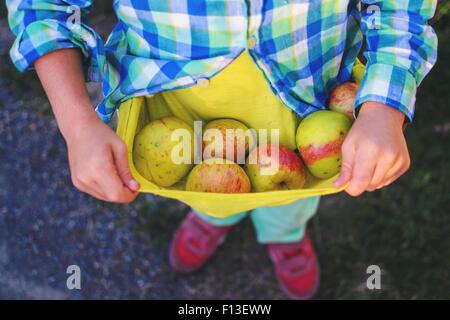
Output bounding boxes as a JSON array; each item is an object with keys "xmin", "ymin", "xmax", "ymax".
[{"xmin": 345, "ymin": 149, "xmax": 376, "ymax": 197}]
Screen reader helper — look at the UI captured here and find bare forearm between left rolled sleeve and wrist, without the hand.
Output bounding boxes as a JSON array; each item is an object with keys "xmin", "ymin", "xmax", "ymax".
[{"xmin": 34, "ymin": 49, "xmax": 100, "ymax": 141}]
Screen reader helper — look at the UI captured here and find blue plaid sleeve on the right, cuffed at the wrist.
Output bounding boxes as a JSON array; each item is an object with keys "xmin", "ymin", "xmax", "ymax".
[{"xmin": 355, "ymin": 0, "xmax": 437, "ymax": 121}]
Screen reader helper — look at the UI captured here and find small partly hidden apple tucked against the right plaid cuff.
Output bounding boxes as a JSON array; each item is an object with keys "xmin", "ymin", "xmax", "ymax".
[{"xmin": 328, "ymin": 82, "xmax": 359, "ymax": 120}]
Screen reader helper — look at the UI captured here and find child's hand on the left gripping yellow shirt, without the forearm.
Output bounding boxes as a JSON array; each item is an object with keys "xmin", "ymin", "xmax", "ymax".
[{"xmin": 66, "ymin": 117, "xmax": 139, "ymax": 203}]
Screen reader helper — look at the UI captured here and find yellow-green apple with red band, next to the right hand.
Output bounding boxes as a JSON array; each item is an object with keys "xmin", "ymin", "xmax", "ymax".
[{"xmin": 296, "ymin": 110, "xmax": 352, "ymax": 179}]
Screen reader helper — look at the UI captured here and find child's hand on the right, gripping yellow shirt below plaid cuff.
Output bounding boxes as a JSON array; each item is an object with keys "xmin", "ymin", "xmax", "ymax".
[{"xmin": 334, "ymin": 102, "xmax": 410, "ymax": 196}]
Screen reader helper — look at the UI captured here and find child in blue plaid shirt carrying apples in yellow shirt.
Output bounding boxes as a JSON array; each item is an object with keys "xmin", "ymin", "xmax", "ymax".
[{"xmin": 6, "ymin": 0, "xmax": 437, "ymax": 299}]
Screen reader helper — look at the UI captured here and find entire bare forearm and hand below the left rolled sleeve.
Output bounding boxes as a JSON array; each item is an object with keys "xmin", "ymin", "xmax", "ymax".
[{"xmin": 34, "ymin": 48, "xmax": 139, "ymax": 203}]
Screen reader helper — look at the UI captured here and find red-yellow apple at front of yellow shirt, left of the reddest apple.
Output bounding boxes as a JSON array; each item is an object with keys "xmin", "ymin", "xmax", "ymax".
[{"xmin": 186, "ymin": 158, "xmax": 251, "ymax": 193}]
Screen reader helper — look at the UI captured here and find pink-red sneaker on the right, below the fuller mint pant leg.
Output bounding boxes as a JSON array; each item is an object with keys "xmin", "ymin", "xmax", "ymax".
[{"xmin": 267, "ymin": 234, "xmax": 320, "ymax": 300}]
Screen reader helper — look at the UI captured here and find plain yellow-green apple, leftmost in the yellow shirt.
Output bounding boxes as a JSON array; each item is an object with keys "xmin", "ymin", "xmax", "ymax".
[{"xmin": 133, "ymin": 117, "xmax": 194, "ymax": 187}]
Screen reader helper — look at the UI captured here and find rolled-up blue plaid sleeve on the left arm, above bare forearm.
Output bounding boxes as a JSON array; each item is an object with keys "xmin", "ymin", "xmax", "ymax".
[{"xmin": 6, "ymin": 0, "xmax": 97, "ymax": 71}]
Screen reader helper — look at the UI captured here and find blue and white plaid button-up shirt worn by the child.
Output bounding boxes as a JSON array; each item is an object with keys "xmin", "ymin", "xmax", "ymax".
[{"xmin": 6, "ymin": 0, "xmax": 437, "ymax": 121}]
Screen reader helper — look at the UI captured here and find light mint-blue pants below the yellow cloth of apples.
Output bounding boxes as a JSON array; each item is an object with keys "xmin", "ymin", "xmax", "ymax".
[{"xmin": 194, "ymin": 197, "xmax": 320, "ymax": 243}]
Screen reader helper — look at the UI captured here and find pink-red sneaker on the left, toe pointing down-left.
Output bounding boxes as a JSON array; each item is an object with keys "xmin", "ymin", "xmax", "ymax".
[{"xmin": 169, "ymin": 212, "xmax": 231, "ymax": 273}]
